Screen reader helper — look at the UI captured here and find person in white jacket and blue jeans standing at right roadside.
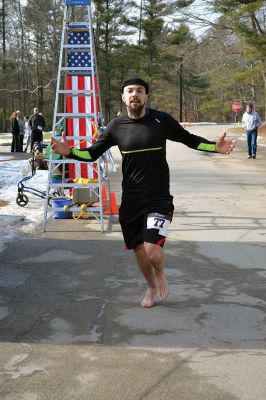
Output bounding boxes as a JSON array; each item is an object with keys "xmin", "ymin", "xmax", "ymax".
[{"xmin": 242, "ymin": 103, "xmax": 262, "ymax": 159}]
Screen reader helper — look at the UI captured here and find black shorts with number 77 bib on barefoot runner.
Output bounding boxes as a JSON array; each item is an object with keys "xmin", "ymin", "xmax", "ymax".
[{"xmin": 119, "ymin": 197, "xmax": 173, "ymax": 249}]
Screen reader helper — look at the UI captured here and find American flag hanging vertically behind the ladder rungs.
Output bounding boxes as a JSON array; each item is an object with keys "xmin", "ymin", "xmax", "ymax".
[{"xmin": 66, "ymin": 30, "xmax": 98, "ymax": 180}]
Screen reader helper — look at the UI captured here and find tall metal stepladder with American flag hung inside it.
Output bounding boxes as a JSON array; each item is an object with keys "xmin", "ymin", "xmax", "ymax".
[{"xmin": 43, "ymin": 0, "xmax": 113, "ymax": 232}]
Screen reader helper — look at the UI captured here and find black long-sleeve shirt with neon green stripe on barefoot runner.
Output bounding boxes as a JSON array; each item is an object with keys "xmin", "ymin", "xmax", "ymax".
[{"xmin": 69, "ymin": 109, "xmax": 216, "ymax": 198}]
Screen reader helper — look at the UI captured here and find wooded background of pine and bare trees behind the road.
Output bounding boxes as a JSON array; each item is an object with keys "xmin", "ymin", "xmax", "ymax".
[{"xmin": 0, "ymin": 0, "xmax": 266, "ymax": 132}]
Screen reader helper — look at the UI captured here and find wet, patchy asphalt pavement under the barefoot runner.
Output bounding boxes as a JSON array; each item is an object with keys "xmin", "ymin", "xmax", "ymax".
[{"xmin": 0, "ymin": 126, "xmax": 266, "ymax": 400}]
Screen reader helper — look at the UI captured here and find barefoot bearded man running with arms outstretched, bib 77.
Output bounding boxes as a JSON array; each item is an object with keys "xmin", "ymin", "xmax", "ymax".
[{"xmin": 51, "ymin": 78, "xmax": 235, "ymax": 308}]
